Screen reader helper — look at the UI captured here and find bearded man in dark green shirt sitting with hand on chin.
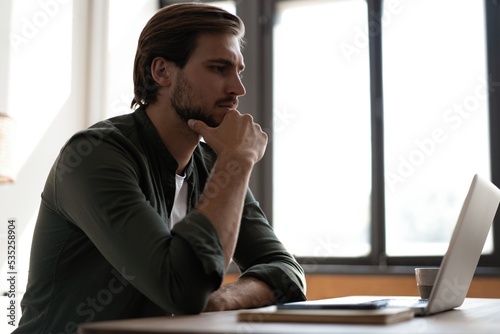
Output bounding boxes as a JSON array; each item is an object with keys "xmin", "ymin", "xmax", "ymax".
[{"xmin": 16, "ymin": 4, "xmax": 305, "ymax": 333}]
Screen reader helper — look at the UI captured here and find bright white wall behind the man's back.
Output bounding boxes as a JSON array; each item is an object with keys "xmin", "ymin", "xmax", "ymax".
[{"xmin": 0, "ymin": 0, "xmax": 158, "ymax": 333}]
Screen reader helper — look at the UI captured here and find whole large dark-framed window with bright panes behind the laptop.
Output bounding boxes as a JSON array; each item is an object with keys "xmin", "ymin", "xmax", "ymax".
[{"xmin": 161, "ymin": 0, "xmax": 500, "ymax": 272}]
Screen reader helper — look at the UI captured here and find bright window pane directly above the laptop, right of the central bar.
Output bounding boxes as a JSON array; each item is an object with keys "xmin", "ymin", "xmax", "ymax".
[{"xmin": 382, "ymin": 0, "xmax": 492, "ymax": 256}]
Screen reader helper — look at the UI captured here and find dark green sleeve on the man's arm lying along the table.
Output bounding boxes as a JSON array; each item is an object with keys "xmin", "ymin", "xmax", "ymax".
[{"xmin": 233, "ymin": 190, "xmax": 306, "ymax": 303}]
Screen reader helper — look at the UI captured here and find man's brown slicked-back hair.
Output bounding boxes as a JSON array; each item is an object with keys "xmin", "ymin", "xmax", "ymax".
[{"xmin": 131, "ymin": 3, "xmax": 245, "ymax": 108}]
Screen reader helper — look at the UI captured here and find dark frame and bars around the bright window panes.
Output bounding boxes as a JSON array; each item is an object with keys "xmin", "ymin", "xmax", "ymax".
[{"xmin": 160, "ymin": 0, "xmax": 500, "ymax": 276}]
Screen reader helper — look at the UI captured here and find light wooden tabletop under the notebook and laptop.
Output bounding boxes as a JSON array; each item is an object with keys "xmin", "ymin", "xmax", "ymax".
[{"xmin": 78, "ymin": 298, "xmax": 500, "ymax": 334}]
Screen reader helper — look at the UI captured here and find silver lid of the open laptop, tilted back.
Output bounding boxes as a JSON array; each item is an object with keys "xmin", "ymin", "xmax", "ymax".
[{"xmin": 426, "ymin": 175, "xmax": 500, "ymax": 314}]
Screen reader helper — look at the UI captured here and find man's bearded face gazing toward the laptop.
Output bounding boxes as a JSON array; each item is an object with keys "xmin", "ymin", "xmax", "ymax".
[{"xmin": 170, "ymin": 34, "xmax": 245, "ymax": 127}]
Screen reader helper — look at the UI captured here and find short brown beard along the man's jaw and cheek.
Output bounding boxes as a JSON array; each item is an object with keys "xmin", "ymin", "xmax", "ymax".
[{"xmin": 170, "ymin": 72, "xmax": 219, "ymax": 128}]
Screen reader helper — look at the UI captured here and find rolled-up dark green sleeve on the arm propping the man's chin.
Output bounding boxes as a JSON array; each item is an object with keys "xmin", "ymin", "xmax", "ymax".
[{"xmin": 52, "ymin": 132, "xmax": 224, "ymax": 314}]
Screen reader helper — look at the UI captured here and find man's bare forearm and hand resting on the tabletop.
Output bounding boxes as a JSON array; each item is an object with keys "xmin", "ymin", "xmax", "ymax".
[{"xmin": 205, "ymin": 277, "xmax": 274, "ymax": 312}]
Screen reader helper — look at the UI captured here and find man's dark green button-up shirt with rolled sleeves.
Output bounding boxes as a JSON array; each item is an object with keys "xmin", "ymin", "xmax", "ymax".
[{"xmin": 15, "ymin": 109, "xmax": 305, "ymax": 334}]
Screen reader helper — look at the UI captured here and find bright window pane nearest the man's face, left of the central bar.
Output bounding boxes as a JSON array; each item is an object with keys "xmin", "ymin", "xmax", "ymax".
[{"xmin": 272, "ymin": 0, "xmax": 371, "ymax": 257}]
